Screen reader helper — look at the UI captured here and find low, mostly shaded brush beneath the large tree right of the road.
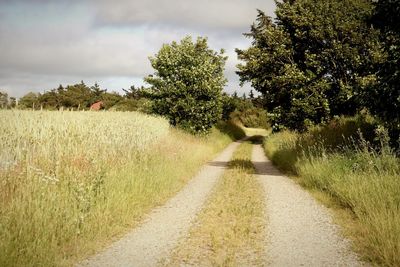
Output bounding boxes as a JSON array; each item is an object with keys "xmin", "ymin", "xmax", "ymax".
[{"xmin": 265, "ymin": 115, "xmax": 380, "ymax": 174}]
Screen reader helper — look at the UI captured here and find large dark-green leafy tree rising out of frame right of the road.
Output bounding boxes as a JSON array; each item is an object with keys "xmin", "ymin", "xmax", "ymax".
[{"xmin": 236, "ymin": 0, "xmax": 380, "ymax": 130}]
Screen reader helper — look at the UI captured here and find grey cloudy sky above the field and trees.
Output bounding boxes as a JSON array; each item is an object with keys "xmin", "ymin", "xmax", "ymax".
[{"xmin": 0, "ymin": 0, "xmax": 275, "ymax": 97}]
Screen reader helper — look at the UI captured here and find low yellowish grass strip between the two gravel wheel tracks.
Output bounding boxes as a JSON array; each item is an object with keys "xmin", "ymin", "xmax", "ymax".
[{"xmin": 164, "ymin": 143, "xmax": 265, "ymax": 266}]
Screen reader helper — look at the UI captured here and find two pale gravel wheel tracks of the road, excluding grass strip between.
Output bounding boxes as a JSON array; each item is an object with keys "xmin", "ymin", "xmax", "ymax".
[{"xmin": 79, "ymin": 142, "xmax": 364, "ymax": 266}]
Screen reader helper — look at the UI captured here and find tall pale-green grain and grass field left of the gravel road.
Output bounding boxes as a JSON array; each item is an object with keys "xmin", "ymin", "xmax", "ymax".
[{"xmin": 0, "ymin": 111, "xmax": 230, "ymax": 266}]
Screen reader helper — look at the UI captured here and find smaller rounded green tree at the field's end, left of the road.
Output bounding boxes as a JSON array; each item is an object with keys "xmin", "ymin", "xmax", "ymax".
[{"xmin": 145, "ymin": 37, "xmax": 227, "ymax": 133}]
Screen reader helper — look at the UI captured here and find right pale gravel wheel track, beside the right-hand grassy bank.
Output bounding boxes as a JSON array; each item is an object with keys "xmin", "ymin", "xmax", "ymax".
[{"xmin": 252, "ymin": 145, "xmax": 363, "ymax": 266}]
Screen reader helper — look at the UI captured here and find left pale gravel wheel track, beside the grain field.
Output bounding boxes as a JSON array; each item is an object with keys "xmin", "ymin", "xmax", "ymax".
[{"xmin": 78, "ymin": 142, "xmax": 239, "ymax": 266}]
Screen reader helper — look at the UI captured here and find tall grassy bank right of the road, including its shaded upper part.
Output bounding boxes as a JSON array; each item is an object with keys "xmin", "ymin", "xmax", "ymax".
[{"xmin": 264, "ymin": 119, "xmax": 400, "ymax": 266}]
